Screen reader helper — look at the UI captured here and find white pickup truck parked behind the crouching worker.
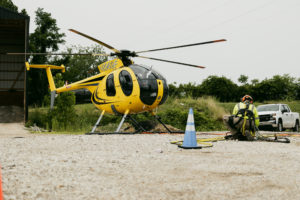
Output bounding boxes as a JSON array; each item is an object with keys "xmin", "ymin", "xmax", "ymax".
[{"xmin": 257, "ymin": 104, "xmax": 299, "ymax": 132}]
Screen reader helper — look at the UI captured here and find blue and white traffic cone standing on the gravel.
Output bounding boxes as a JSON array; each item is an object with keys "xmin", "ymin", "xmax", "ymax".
[{"xmin": 179, "ymin": 108, "xmax": 202, "ymax": 149}]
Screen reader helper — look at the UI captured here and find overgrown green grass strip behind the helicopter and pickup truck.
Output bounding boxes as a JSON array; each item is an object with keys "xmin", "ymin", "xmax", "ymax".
[{"xmin": 26, "ymin": 97, "xmax": 300, "ymax": 134}]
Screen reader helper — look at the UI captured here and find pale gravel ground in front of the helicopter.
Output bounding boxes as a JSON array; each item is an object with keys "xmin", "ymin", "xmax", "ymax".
[{"xmin": 0, "ymin": 124, "xmax": 300, "ymax": 200}]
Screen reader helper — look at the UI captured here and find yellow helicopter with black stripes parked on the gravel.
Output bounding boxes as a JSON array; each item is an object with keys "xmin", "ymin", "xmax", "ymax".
[{"xmin": 20, "ymin": 29, "xmax": 226, "ymax": 133}]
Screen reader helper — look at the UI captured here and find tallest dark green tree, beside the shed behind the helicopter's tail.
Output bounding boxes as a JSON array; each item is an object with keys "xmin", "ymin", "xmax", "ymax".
[{"xmin": 28, "ymin": 8, "xmax": 65, "ymax": 105}]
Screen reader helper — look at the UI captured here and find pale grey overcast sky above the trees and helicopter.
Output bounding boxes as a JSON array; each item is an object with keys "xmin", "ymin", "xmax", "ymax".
[{"xmin": 13, "ymin": 0, "xmax": 300, "ymax": 84}]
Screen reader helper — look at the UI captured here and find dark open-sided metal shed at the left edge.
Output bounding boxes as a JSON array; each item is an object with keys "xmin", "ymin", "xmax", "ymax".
[{"xmin": 0, "ymin": 7, "xmax": 30, "ymax": 123}]
